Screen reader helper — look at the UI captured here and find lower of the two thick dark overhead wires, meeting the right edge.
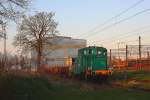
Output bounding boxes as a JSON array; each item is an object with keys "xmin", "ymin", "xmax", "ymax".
[{"xmin": 85, "ymin": 8, "xmax": 150, "ymax": 38}]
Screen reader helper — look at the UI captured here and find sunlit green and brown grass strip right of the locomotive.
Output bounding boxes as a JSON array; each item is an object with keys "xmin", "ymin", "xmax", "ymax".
[{"xmin": 109, "ymin": 70, "xmax": 150, "ymax": 89}]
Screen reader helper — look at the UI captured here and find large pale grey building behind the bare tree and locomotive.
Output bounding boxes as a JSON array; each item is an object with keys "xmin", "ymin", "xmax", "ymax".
[{"xmin": 31, "ymin": 36, "xmax": 86, "ymax": 66}]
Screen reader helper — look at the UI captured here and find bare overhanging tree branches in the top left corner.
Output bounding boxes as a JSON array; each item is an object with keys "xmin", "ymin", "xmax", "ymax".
[{"xmin": 0, "ymin": 0, "xmax": 33, "ymax": 20}]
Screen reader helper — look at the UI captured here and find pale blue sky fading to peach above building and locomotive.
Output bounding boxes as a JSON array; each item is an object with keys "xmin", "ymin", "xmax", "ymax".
[{"xmin": 0, "ymin": 0, "xmax": 150, "ymax": 54}]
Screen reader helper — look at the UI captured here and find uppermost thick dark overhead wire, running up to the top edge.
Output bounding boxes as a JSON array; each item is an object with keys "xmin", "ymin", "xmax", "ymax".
[{"xmin": 77, "ymin": 0, "xmax": 144, "ymax": 37}]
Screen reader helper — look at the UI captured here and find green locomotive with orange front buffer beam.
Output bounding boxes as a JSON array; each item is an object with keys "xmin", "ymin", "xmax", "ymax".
[{"xmin": 74, "ymin": 46, "xmax": 111, "ymax": 76}]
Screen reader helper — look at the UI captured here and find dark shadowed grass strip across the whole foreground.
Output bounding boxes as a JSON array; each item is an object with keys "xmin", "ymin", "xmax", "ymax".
[{"xmin": 0, "ymin": 72, "xmax": 150, "ymax": 100}]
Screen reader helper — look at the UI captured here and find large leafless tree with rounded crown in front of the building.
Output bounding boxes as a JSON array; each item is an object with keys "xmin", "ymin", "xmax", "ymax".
[{"xmin": 14, "ymin": 12, "xmax": 57, "ymax": 70}]
